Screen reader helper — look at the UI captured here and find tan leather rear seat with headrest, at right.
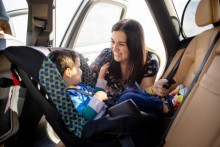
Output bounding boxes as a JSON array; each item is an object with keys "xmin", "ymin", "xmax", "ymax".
[{"xmin": 164, "ymin": 0, "xmax": 220, "ymax": 147}]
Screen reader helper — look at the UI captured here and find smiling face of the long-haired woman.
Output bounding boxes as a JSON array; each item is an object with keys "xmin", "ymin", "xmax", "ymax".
[{"xmin": 111, "ymin": 31, "xmax": 129, "ymax": 63}]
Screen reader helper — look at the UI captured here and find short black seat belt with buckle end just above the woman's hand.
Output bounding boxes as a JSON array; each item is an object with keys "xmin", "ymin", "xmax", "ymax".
[{"xmin": 163, "ymin": 49, "xmax": 186, "ymax": 89}]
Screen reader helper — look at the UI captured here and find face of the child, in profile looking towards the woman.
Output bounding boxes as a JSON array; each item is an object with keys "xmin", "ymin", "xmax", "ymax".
[{"xmin": 70, "ymin": 58, "xmax": 82, "ymax": 85}]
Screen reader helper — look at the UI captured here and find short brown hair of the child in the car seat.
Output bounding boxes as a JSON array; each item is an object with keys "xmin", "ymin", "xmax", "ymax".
[{"xmin": 48, "ymin": 49, "xmax": 79, "ymax": 76}]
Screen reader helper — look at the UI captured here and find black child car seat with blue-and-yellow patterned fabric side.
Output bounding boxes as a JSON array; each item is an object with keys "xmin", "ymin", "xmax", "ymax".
[{"xmin": 4, "ymin": 46, "xmax": 161, "ymax": 147}]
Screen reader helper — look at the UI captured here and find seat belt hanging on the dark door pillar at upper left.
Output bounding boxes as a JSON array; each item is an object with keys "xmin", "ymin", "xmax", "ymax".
[{"xmin": 28, "ymin": 17, "xmax": 47, "ymax": 46}]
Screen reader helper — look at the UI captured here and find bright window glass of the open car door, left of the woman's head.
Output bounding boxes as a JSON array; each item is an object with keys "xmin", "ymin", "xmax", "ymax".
[{"xmin": 75, "ymin": 3, "xmax": 122, "ymax": 64}]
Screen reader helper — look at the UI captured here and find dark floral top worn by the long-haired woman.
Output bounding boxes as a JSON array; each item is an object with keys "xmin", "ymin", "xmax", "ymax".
[{"xmin": 90, "ymin": 48, "xmax": 159, "ymax": 106}]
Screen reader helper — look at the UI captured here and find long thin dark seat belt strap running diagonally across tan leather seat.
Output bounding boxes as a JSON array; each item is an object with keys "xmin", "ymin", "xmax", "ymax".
[{"xmin": 158, "ymin": 32, "xmax": 220, "ymax": 147}]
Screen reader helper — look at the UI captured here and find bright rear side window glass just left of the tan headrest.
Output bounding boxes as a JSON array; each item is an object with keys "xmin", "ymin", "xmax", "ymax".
[{"xmin": 173, "ymin": 0, "xmax": 212, "ymax": 37}]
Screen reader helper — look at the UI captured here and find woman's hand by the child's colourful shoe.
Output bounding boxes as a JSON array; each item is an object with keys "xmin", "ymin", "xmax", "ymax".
[{"xmin": 152, "ymin": 79, "xmax": 169, "ymax": 97}]
